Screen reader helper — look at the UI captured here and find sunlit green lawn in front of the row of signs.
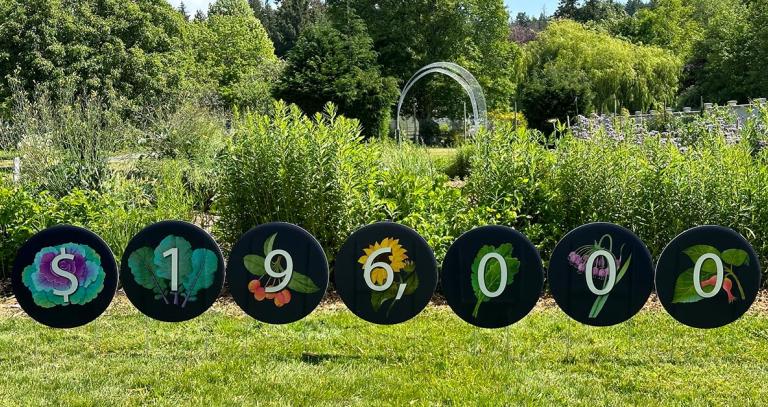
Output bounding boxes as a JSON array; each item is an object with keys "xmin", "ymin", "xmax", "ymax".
[{"xmin": 0, "ymin": 300, "xmax": 768, "ymax": 406}]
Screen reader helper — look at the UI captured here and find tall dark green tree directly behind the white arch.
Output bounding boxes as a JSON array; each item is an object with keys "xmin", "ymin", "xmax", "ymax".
[{"xmin": 329, "ymin": 0, "xmax": 521, "ymax": 118}]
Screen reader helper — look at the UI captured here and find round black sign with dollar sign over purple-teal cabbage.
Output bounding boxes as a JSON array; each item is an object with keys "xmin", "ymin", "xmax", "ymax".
[{"xmin": 11, "ymin": 225, "xmax": 117, "ymax": 328}]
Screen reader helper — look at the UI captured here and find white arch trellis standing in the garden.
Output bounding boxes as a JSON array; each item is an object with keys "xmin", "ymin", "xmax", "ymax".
[{"xmin": 397, "ymin": 62, "xmax": 488, "ymax": 141}]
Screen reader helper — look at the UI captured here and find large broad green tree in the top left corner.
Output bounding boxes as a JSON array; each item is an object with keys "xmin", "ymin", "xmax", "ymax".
[{"xmin": 0, "ymin": 0, "xmax": 192, "ymax": 116}]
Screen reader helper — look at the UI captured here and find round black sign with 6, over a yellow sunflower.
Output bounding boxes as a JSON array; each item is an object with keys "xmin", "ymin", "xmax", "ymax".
[{"xmin": 335, "ymin": 222, "xmax": 437, "ymax": 325}]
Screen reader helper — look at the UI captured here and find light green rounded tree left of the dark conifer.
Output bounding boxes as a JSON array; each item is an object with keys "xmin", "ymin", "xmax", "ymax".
[{"xmin": 192, "ymin": 0, "xmax": 280, "ymax": 110}]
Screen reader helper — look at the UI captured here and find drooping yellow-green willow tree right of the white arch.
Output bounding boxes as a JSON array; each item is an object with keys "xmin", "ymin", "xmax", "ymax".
[{"xmin": 520, "ymin": 20, "xmax": 682, "ymax": 129}]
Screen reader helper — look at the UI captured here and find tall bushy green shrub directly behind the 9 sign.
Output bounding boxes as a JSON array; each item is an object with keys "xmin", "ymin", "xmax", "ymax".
[{"xmin": 215, "ymin": 103, "xmax": 378, "ymax": 258}]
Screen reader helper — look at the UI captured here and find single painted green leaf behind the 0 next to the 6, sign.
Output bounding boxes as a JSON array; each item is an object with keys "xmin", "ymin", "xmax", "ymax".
[{"xmin": 471, "ymin": 243, "xmax": 520, "ymax": 318}]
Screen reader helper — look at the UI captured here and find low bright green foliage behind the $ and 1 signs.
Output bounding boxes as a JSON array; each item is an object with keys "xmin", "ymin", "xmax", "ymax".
[{"xmin": 0, "ymin": 162, "xmax": 193, "ymax": 278}]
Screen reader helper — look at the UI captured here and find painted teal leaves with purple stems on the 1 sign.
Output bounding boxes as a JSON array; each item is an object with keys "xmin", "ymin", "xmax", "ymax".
[{"xmin": 128, "ymin": 235, "xmax": 219, "ymax": 307}]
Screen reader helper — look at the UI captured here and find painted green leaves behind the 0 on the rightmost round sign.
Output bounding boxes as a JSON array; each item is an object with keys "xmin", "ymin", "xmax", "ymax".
[{"xmin": 672, "ymin": 245, "xmax": 749, "ymax": 304}]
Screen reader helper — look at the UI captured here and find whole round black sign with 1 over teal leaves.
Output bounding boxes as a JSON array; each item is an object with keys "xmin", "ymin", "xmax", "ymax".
[{"xmin": 120, "ymin": 221, "xmax": 224, "ymax": 322}]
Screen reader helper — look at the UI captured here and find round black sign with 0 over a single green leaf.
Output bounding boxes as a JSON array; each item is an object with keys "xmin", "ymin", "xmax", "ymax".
[{"xmin": 441, "ymin": 226, "xmax": 544, "ymax": 328}]
